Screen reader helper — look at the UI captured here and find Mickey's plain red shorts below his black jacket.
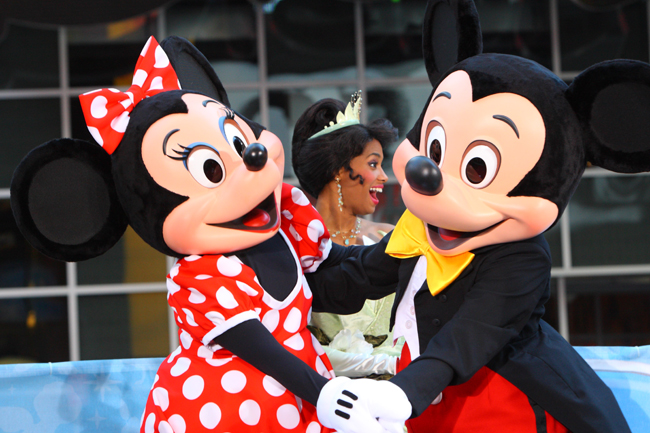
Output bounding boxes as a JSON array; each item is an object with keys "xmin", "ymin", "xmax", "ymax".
[{"xmin": 397, "ymin": 344, "xmax": 569, "ymax": 433}]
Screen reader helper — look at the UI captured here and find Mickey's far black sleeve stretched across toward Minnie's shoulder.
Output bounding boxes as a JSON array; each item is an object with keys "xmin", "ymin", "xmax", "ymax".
[{"xmin": 305, "ymin": 233, "xmax": 400, "ymax": 314}]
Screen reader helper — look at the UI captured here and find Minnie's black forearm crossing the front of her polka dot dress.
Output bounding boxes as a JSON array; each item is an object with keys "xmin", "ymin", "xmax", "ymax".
[{"xmin": 213, "ymin": 319, "xmax": 328, "ymax": 406}]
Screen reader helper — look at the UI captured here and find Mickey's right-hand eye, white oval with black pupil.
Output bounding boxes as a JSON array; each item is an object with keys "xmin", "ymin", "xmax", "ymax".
[{"xmin": 460, "ymin": 141, "xmax": 501, "ymax": 189}]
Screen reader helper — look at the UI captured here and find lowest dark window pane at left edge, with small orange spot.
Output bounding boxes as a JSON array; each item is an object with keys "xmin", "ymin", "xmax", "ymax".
[{"xmin": 0, "ymin": 297, "xmax": 70, "ymax": 364}]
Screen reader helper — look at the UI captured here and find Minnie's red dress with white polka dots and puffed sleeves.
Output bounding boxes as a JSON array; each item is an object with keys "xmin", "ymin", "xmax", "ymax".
[{"xmin": 140, "ymin": 185, "xmax": 333, "ymax": 433}]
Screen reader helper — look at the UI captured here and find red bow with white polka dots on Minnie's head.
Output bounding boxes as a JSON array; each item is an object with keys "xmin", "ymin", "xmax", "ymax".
[{"xmin": 79, "ymin": 36, "xmax": 181, "ymax": 154}]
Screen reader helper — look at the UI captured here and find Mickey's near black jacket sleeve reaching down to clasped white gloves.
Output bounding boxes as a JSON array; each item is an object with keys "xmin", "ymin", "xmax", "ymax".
[{"xmin": 391, "ymin": 243, "xmax": 551, "ymax": 416}]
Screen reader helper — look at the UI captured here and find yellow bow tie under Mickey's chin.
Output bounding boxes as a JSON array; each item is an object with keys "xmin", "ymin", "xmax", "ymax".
[{"xmin": 386, "ymin": 210, "xmax": 474, "ymax": 296}]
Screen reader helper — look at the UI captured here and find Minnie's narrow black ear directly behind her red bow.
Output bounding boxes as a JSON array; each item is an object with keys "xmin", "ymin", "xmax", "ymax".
[{"xmin": 160, "ymin": 36, "xmax": 230, "ymax": 107}]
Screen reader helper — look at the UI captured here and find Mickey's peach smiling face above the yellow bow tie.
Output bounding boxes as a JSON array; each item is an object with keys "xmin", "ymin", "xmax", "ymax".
[{"xmin": 393, "ymin": 71, "xmax": 558, "ymax": 256}]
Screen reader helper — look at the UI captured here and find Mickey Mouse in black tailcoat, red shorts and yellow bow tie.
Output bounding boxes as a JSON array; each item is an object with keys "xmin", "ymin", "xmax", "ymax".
[{"xmin": 308, "ymin": 0, "xmax": 650, "ymax": 433}]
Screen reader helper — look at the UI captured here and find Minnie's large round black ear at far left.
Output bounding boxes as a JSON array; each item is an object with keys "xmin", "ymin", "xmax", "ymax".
[{"xmin": 11, "ymin": 138, "xmax": 127, "ymax": 262}]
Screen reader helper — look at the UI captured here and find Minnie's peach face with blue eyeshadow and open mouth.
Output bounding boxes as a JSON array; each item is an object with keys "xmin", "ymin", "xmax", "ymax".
[{"xmin": 142, "ymin": 93, "xmax": 284, "ymax": 254}]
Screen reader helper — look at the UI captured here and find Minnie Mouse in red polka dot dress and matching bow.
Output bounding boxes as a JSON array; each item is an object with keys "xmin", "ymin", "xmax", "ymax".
[{"xmin": 11, "ymin": 37, "xmax": 410, "ymax": 433}]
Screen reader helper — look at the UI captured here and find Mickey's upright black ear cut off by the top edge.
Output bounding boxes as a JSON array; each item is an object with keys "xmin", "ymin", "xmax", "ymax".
[{"xmin": 422, "ymin": 0, "xmax": 483, "ymax": 87}]
